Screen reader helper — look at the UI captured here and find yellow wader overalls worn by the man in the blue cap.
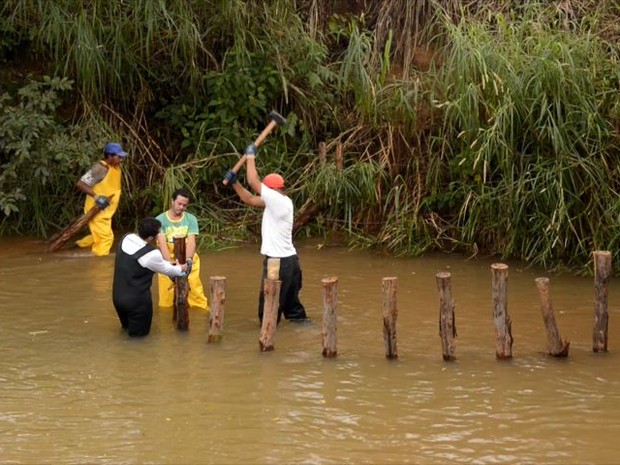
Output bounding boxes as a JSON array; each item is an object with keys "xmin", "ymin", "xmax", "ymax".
[{"xmin": 76, "ymin": 161, "xmax": 122, "ymax": 256}]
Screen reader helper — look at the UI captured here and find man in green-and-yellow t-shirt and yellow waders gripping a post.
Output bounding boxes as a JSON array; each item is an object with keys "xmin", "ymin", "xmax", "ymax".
[{"xmin": 157, "ymin": 189, "xmax": 209, "ymax": 310}]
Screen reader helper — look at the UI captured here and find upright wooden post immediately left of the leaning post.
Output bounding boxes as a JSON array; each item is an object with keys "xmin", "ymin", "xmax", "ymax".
[{"xmin": 491, "ymin": 263, "xmax": 512, "ymax": 359}]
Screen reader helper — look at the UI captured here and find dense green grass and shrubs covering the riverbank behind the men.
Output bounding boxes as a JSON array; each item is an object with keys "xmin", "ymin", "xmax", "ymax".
[{"xmin": 0, "ymin": 0, "xmax": 620, "ymax": 271}]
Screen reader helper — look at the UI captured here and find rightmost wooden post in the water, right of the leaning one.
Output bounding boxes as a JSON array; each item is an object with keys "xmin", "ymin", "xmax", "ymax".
[{"xmin": 592, "ymin": 250, "xmax": 611, "ymax": 352}]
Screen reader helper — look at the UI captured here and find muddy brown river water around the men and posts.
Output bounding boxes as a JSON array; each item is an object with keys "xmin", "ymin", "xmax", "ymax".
[{"xmin": 0, "ymin": 239, "xmax": 620, "ymax": 465}]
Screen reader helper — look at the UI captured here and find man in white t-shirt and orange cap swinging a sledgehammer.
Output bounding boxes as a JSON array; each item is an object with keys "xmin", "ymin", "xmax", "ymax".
[{"xmin": 225, "ymin": 144, "xmax": 309, "ymax": 322}]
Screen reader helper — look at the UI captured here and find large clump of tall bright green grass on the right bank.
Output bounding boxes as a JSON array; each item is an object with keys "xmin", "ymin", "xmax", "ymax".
[{"xmin": 431, "ymin": 3, "xmax": 619, "ymax": 266}]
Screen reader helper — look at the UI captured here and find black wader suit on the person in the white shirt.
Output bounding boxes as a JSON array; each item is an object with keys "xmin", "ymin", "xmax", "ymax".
[{"xmin": 112, "ymin": 237, "xmax": 155, "ymax": 337}]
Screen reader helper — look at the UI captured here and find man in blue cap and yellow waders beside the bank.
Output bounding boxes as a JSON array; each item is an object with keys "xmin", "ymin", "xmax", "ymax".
[{"xmin": 76, "ymin": 142, "xmax": 127, "ymax": 256}]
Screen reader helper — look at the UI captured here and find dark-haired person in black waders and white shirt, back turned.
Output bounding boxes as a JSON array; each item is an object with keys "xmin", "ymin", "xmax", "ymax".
[{"xmin": 112, "ymin": 217, "xmax": 188, "ymax": 337}]
